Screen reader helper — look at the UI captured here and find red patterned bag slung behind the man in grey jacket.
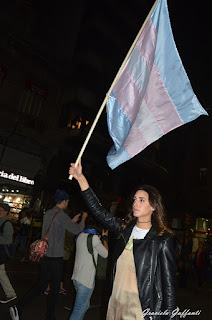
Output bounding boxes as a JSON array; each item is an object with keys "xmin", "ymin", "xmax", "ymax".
[{"xmin": 29, "ymin": 211, "xmax": 60, "ymax": 262}]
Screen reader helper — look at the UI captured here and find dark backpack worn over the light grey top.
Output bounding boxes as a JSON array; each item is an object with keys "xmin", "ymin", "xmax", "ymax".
[{"xmin": 87, "ymin": 233, "xmax": 107, "ymax": 280}]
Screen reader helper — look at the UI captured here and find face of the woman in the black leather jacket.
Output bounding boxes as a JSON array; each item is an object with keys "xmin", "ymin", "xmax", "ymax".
[{"xmin": 132, "ymin": 190, "xmax": 154, "ymax": 219}]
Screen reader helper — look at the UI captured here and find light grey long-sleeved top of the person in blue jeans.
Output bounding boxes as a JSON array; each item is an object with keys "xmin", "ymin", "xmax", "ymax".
[{"xmin": 71, "ymin": 232, "xmax": 108, "ymax": 289}]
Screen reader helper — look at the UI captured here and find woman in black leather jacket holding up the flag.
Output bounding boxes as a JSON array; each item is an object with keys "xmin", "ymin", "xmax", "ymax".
[{"xmin": 69, "ymin": 162, "xmax": 176, "ymax": 320}]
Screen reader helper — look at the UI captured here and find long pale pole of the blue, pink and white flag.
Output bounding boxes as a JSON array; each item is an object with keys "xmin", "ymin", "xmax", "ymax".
[{"xmin": 69, "ymin": 0, "xmax": 159, "ymax": 180}]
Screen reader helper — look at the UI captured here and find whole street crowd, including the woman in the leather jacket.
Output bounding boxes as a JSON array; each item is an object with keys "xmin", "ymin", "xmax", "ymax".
[{"xmin": 0, "ymin": 162, "xmax": 212, "ymax": 320}]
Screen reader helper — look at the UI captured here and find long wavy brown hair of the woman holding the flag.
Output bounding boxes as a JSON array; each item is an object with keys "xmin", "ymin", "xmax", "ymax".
[{"xmin": 123, "ymin": 185, "xmax": 173, "ymax": 236}]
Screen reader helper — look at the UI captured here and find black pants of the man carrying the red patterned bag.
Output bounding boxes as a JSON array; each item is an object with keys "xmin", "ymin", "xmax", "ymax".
[{"xmin": 17, "ymin": 257, "xmax": 63, "ymax": 320}]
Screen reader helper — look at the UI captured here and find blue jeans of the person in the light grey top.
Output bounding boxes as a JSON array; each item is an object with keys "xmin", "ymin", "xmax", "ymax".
[{"xmin": 69, "ymin": 280, "xmax": 95, "ymax": 320}]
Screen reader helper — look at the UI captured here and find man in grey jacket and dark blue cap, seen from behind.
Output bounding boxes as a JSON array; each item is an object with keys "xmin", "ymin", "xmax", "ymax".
[{"xmin": 10, "ymin": 189, "xmax": 87, "ymax": 320}]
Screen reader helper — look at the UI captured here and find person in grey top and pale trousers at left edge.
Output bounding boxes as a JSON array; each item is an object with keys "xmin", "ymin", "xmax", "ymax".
[{"xmin": 0, "ymin": 203, "xmax": 17, "ymax": 303}]
